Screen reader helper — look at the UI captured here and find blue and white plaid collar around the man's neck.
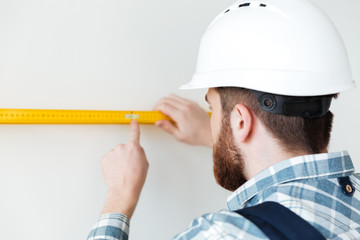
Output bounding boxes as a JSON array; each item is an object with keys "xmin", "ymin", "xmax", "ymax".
[{"xmin": 228, "ymin": 151, "xmax": 355, "ymax": 211}]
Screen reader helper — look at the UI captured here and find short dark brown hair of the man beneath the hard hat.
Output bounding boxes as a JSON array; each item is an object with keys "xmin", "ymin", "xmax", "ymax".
[{"xmin": 216, "ymin": 87, "xmax": 337, "ymax": 154}]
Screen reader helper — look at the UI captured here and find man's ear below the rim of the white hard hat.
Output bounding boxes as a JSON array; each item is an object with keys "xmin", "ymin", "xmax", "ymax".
[{"xmin": 231, "ymin": 104, "xmax": 254, "ymax": 143}]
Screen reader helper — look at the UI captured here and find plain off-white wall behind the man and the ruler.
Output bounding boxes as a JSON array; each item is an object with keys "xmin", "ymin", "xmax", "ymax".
[{"xmin": 0, "ymin": 0, "xmax": 360, "ymax": 240}]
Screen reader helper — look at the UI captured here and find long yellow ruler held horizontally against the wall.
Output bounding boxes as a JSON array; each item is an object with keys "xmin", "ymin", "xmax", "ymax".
[{"xmin": 0, "ymin": 109, "xmax": 171, "ymax": 124}]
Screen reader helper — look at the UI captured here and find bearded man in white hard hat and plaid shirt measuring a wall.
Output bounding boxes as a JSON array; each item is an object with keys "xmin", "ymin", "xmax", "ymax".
[{"xmin": 89, "ymin": 0, "xmax": 360, "ymax": 239}]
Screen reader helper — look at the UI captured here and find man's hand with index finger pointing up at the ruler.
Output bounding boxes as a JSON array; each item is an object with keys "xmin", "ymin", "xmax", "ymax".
[{"xmin": 101, "ymin": 121, "xmax": 149, "ymax": 219}]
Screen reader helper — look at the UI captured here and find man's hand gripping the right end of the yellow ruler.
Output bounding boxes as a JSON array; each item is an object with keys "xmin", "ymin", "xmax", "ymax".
[{"xmin": 154, "ymin": 95, "xmax": 213, "ymax": 148}]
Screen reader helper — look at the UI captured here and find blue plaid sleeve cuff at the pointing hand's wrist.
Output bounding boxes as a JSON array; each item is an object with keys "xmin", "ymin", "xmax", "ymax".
[{"xmin": 87, "ymin": 213, "xmax": 129, "ymax": 240}]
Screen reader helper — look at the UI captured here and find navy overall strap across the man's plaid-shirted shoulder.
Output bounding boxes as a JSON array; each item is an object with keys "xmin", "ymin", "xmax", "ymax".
[{"xmin": 235, "ymin": 202, "xmax": 325, "ymax": 240}]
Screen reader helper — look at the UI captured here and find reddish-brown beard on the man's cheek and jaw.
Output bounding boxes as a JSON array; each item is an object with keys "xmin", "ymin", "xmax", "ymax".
[{"xmin": 213, "ymin": 116, "xmax": 247, "ymax": 191}]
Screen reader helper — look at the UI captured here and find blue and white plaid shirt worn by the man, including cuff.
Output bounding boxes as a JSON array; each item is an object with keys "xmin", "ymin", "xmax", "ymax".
[{"xmin": 88, "ymin": 151, "xmax": 360, "ymax": 240}]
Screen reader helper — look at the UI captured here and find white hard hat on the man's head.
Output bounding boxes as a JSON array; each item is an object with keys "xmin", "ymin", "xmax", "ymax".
[{"xmin": 181, "ymin": 0, "xmax": 355, "ymax": 96}]
